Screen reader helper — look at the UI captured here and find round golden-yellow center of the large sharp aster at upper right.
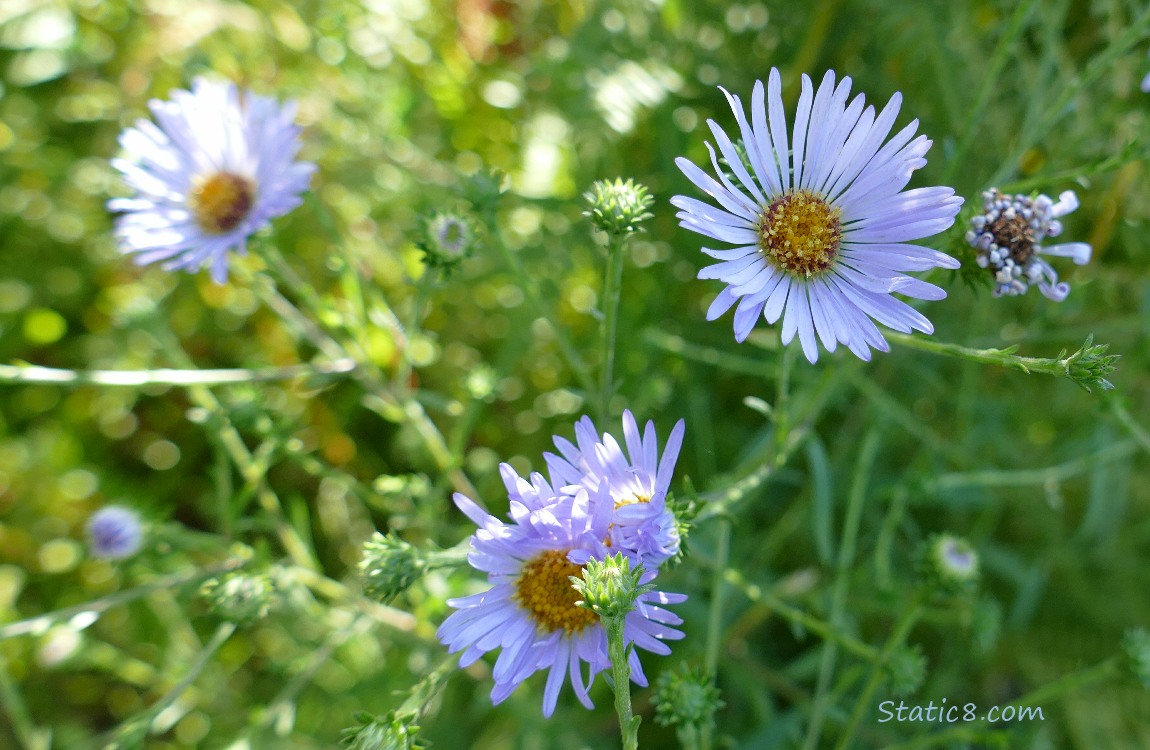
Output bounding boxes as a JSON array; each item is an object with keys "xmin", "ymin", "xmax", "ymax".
[{"xmin": 759, "ymin": 190, "xmax": 843, "ymax": 278}]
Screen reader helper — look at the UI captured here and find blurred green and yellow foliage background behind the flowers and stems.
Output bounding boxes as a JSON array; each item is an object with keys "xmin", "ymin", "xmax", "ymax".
[{"xmin": 0, "ymin": 0, "xmax": 1150, "ymax": 748}]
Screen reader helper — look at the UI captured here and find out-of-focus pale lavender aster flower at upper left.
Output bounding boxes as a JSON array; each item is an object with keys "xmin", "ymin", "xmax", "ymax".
[{"xmin": 108, "ymin": 78, "xmax": 315, "ymax": 283}]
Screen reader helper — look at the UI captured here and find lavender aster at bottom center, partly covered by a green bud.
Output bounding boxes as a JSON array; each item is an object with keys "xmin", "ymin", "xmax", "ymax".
[{"xmin": 437, "ymin": 488, "xmax": 687, "ymax": 717}]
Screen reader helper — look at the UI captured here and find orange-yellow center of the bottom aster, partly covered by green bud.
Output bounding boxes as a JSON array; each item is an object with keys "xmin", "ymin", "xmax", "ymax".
[{"xmin": 515, "ymin": 550, "xmax": 599, "ymax": 636}]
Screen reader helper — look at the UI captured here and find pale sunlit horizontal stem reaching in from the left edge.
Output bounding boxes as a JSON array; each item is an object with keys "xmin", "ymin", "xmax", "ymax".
[{"xmin": 0, "ymin": 358, "xmax": 355, "ymax": 388}]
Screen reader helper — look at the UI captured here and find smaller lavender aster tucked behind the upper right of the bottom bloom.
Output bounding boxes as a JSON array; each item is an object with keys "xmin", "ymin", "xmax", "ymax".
[{"xmin": 542, "ymin": 411, "xmax": 684, "ymax": 569}]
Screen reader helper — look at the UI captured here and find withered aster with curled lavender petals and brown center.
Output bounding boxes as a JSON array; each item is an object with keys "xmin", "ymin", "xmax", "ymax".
[{"xmin": 966, "ymin": 188, "xmax": 1091, "ymax": 303}]
